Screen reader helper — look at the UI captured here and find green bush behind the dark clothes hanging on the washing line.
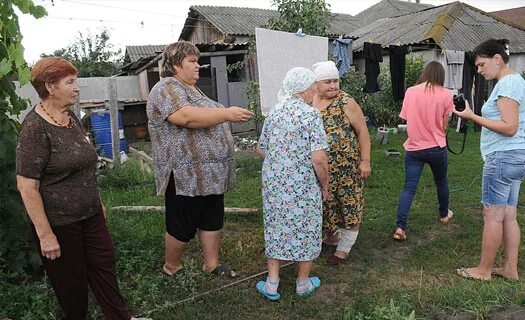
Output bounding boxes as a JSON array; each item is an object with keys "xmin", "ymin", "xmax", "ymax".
[{"xmin": 341, "ymin": 54, "xmax": 424, "ymax": 127}]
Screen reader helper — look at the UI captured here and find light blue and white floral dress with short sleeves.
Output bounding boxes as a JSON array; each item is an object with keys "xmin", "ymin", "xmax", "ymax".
[{"xmin": 259, "ymin": 98, "xmax": 328, "ymax": 261}]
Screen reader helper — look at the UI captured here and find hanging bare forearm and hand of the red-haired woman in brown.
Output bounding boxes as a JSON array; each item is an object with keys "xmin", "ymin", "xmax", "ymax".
[{"xmin": 16, "ymin": 175, "xmax": 61, "ymax": 260}]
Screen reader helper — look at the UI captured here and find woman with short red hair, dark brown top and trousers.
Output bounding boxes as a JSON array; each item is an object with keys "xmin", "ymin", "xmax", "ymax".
[{"xmin": 16, "ymin": 57, "xmax": 148, "ymax": 320}]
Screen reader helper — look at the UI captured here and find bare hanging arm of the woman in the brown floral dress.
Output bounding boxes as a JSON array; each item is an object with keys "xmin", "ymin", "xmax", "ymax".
[{"xmin": 344, "ymin": 99, "xmax": 372, "ymax": 179}]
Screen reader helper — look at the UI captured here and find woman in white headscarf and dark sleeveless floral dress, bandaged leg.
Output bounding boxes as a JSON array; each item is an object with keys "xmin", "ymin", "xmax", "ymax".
[{"xmin": 313, "ymin": 61, "xmax": 372, "ymax": 265}]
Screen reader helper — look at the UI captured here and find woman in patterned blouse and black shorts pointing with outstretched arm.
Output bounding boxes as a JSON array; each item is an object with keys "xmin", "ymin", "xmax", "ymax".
[{"xmin": 147, "ymin": 41, "xmax": 252, "ymax": 277}]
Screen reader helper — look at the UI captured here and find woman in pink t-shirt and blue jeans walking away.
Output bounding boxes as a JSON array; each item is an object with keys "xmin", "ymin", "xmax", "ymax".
[{"xmin": 394, "ymin": 61, "xmax": 454, "ymax": 241}]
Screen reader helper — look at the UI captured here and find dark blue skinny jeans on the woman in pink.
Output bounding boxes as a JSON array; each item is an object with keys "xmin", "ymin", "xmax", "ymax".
[{"xmin": 397, "ymin": 147, "xmax": 448, "ymax": 230}]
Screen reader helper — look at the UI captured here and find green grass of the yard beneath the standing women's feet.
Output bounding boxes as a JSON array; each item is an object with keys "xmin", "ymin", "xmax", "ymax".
[{"xmin": 0, "ymin": 132, "xmax": 525, "ymax": 320}]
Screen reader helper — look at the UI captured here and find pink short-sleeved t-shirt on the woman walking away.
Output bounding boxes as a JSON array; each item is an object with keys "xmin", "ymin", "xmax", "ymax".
[{"xmin": 399, "ymin": 84, "xmax": 454, "ymax": 151}]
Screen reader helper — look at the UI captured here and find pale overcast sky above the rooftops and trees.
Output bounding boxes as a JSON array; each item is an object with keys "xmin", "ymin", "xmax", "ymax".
[{"xmin": 19, "ymin": 0, "xmax": 525, "ymax": 64}]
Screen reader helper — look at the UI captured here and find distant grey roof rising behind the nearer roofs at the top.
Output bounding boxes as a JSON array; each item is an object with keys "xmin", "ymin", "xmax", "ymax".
[{"xmin": 354, "ymin": 0, "xmax": 432, "ymax": 25}]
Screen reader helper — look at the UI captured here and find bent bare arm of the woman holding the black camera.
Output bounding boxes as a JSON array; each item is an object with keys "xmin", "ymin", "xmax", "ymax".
[{"xmin": 454, "ymin": 97, "xmax": 519, "ymax": 137}]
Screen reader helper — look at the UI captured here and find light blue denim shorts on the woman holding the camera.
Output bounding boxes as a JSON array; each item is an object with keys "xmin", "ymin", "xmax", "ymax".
[{"xmin": 481, "ymin": 149, "xmax": 525, "ymax": 206}]
